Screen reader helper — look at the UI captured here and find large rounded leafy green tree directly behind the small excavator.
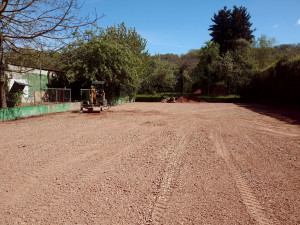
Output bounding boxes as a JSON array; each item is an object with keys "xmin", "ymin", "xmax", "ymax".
[{"xmin": 63, "ymin": 23, "xmax": 148, "ymax": 97}]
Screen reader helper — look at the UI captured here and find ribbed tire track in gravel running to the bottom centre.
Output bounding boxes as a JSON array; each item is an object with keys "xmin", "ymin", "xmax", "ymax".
[{"xmin": 150, "ymin": 122, "xmax": 196, "ymax": 224}]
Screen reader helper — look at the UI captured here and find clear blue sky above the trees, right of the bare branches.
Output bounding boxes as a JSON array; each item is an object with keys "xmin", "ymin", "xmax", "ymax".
[{"xmin": 81, "ymin": 0, "xmax": 300, "ymax": 55}]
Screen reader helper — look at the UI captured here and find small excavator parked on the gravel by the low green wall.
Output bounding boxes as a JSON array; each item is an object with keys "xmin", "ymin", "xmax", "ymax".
[{"xmin": 81, "ymin": 81, "xmax": 110, "ymax": 113}]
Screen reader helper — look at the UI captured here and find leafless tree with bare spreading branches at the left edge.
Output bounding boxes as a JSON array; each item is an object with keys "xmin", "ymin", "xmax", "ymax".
[{"xmin": 0, "ymin": 0, "xmax": 98, "ymax": 108}]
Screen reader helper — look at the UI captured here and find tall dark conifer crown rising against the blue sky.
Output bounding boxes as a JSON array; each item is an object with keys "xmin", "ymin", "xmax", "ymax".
[{"xmin": 208, "ymin": 6, "xmax": 254, "ymax": 55}]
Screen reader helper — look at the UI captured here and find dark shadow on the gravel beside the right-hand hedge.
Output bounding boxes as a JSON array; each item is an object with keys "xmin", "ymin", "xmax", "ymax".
[{"xmin": 236, "ymin": 103, "xmax": 300, "ymax": 125}]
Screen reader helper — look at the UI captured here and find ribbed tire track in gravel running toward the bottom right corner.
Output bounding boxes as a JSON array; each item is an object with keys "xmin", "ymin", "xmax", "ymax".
[{"xmin": 211, "ymin": 131, "xmax": 273, "ymax": 225}]
